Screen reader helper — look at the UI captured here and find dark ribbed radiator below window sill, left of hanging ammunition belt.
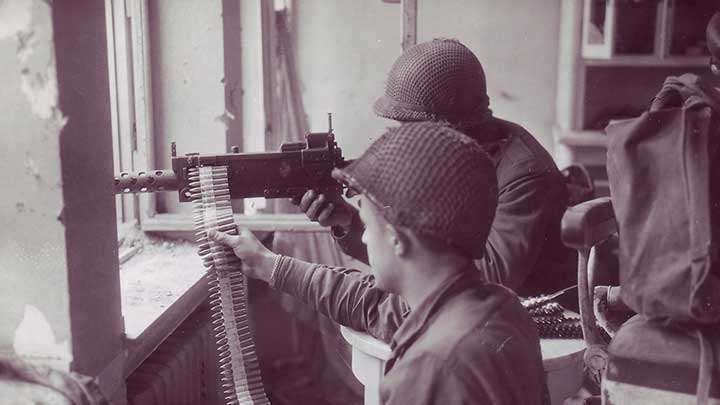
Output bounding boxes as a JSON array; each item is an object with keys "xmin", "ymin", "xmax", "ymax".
[{"xmin": 127, "ymin": 310, "xmax": 220, "ymax": 405}]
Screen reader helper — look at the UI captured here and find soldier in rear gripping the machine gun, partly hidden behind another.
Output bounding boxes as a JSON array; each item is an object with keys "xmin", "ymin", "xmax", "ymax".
[{"xmin": 295, "ymin": 39, "xmax": 576, "ymax": 296}]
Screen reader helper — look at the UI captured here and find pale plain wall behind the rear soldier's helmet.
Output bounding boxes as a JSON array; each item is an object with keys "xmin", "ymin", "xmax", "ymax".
[{"xmin": 296, "ymin": 0, "xmax": 560, "ymax": 157}]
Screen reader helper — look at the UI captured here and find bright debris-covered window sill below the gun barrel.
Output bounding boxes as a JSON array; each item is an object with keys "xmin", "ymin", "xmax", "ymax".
[{"xmin": 120, "ymin": 238, "xmax": 208, "ymax": 377}]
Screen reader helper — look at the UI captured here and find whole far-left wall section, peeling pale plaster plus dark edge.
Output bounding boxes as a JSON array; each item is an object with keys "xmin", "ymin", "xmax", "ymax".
[{"xmin": 0, "ymin": 0, "xmax": 124, "ymax": 400}]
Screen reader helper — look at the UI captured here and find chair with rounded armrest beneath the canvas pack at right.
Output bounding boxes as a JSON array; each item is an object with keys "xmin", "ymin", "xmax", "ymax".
[{"xmin": 562, "ymin": 198, "xmax": 720, "ymax": 405}]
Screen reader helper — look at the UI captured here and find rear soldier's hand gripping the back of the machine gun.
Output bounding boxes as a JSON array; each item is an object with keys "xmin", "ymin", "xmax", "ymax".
[{"xmin": 291, "ymin": 190, "xmax": 355, "ymax": 229}]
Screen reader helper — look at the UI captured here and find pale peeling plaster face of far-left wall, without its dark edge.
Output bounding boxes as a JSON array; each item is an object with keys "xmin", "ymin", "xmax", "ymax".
[{"xmin": 0, "ymin": 0, "xmax": 70, "ymax": 357}]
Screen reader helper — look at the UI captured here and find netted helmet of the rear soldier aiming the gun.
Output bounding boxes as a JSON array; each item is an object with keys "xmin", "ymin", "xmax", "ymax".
[{"xmin": 374, "ymin": 39, "xmax": 490, "ymax": 128}]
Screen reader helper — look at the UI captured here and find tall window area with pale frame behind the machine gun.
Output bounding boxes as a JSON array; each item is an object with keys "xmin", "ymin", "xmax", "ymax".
[{"xmin": 106, "ymin": 0, "xmax": 307, "ymax": 239}]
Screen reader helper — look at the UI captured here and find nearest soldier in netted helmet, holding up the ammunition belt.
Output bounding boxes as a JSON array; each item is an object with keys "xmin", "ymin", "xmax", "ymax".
[{"xmin": 208, "ymin": 122, "xmax": 548, "ymax": 405}]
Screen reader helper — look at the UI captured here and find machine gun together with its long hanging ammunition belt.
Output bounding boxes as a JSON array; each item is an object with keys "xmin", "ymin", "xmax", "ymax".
[{"xmin": 115, "ymin": 114, "xmax": 348, "ymax": 404}]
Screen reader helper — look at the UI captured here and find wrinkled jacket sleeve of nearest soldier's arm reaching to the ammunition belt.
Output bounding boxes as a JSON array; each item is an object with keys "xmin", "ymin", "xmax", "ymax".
[{"xmin": 272, "ymin": 257, "xmax": 410, "ymax": 343}]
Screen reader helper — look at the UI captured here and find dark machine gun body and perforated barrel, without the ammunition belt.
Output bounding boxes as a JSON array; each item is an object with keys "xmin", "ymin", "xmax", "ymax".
[{"xmin": 115, "ymin": 120, "xmax": 348, "ymax": 202}]
